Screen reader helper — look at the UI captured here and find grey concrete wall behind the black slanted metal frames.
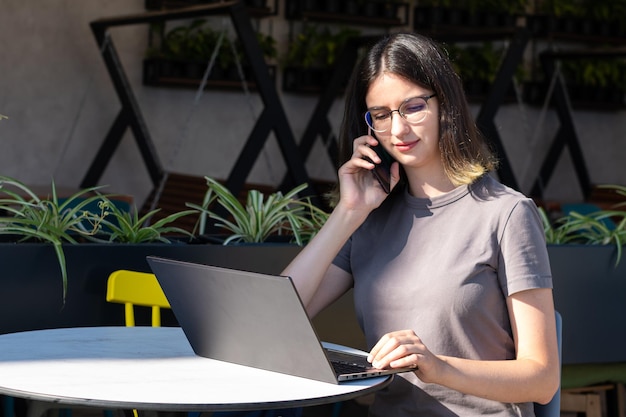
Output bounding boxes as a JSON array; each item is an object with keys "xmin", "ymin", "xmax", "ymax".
[{"xmin": 0, "ymin": 0, "xmax": 626, "ymax": 208}]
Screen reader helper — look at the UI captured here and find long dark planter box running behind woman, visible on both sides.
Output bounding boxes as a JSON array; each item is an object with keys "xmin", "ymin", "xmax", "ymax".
[{"xmin": 7, "ymin": 243, "xmax": 626, "ymax": 364}]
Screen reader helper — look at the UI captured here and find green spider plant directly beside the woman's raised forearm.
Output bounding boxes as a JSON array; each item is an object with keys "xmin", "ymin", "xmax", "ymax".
[{"xmin": 187, "ymin": 177, "xmax": 328, "ymax": 246}]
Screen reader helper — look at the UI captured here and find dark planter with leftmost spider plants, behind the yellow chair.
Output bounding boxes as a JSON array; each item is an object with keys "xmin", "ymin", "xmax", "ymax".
[{"xmin": 0, "ymin": 177, "xmax": 312, "ymax": 333}]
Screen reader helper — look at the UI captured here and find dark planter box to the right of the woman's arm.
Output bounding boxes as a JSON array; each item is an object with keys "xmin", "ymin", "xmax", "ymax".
[{"xmin": 548, "ymin": 245, "xmax": 626, "ymax": 364}]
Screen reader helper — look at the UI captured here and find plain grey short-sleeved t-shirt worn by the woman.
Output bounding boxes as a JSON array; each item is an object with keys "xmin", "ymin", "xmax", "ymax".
[{"xmin": 334, "ymin": 176, "xmax": 552, "ymax": 417}]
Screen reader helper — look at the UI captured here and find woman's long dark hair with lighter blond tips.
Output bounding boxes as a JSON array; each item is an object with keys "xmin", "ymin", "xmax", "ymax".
[{"xmin": 339, "ymin": 33, "xmax": 496, "ymax": 185}]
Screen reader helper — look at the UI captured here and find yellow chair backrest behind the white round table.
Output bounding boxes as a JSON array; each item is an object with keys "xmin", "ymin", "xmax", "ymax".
[{"xmin": 107, "ymin": 270, "xmax": 170, "ymax": 327}]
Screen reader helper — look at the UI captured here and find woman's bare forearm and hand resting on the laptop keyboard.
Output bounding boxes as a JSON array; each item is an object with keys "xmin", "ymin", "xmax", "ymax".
[{"xmin": 371, "ymin": 289, "xmax": 560, "ymax": 403}]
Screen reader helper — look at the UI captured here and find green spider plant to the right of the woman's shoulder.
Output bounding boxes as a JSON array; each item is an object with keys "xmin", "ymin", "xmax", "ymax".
[{"xmin": 540, "ymin": 185, "xmax": 626, "ymax": 265}]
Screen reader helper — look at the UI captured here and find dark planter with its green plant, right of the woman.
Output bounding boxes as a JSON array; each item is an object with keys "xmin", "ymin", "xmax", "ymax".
[{"xmin": 540, "ymin": 185, "xmax": 626, "ymax": 364}]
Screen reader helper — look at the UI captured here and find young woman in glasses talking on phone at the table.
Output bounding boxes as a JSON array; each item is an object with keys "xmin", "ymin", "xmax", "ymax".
[{"xmin": 284, "ymin": 34, "xmax": 559, "ymax": 417}]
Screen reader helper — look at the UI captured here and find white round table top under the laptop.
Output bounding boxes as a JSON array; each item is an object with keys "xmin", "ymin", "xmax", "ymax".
[{"xmin": 0, "ymin": 327, "xmax": 391, "ymax": 411}]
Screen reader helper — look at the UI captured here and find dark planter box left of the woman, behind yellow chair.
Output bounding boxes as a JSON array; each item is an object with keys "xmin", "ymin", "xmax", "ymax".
[{"xmin": 0, "ymin": 243, "xmax": 301, "ymax": 334}]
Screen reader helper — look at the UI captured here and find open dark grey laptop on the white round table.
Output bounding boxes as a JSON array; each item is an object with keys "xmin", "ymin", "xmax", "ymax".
[{"xmin": 147, "ymin": 256, "xmax": 414, "ymax": 384}]
